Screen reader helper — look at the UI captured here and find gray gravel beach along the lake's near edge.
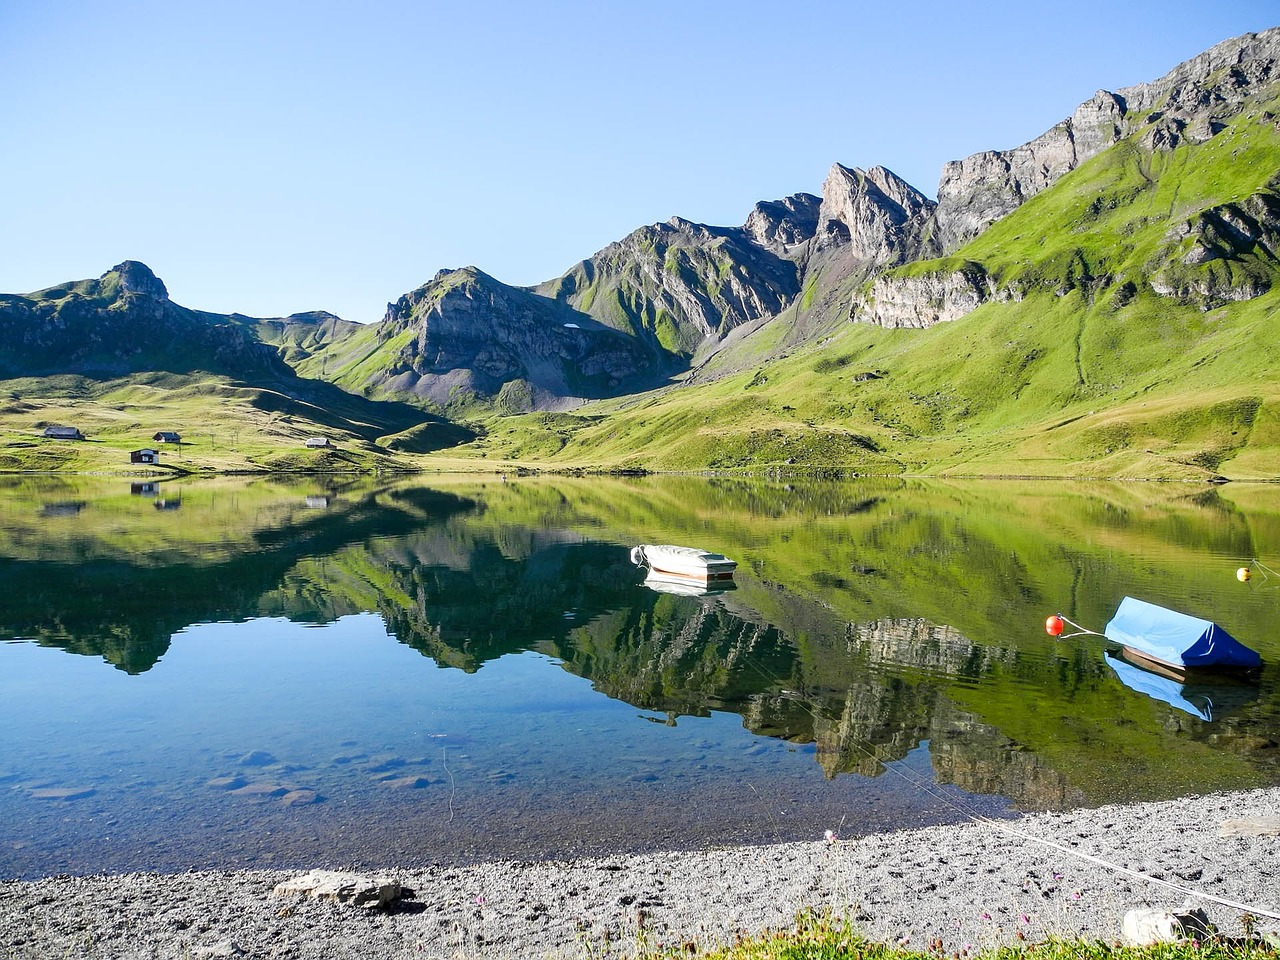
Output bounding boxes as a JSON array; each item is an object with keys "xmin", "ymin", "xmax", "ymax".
[{"xmin": 0, "ymin": 788, "xmax": 1280, "ymax": 960}]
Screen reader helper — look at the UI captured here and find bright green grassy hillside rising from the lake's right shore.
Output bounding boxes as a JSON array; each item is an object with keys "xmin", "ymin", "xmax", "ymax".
[{"xmin": 448, "ymin": 96, "xmax": 1280, "ymax": 479}]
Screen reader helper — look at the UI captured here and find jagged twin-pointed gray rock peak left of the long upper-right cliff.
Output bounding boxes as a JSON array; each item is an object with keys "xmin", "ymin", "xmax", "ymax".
[{"xmin": 818, "ymin": 164, "xmax": 934, "ymax": 265}]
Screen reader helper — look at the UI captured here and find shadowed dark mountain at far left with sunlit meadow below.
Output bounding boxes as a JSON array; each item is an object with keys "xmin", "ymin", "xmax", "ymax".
[{"xmin": 0, "ymin": 260, "xmax": 474, "ymax": 470}]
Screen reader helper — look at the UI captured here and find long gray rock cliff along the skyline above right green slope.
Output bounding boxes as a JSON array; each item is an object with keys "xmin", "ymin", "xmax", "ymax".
[{"xmin": 936, "ymin": 28, "xmax": 1280, "ymax": 251}]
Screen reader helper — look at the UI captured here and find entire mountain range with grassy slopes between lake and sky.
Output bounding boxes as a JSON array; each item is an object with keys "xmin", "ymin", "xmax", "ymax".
[{"xmin": 0, "ymin": 28, "xmax": 1280, "ymax": 479}]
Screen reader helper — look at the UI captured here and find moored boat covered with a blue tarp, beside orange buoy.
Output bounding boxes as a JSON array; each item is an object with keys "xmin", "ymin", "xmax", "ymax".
[{"xmin": 1103, "ymin": 596, "xmax": 1262, "ymax": 669}]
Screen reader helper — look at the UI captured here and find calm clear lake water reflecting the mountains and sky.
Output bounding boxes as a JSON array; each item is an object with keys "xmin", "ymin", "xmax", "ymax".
[{"xmin": 0, "ymin": 477, "xmax": 1280, "ymax": 877}]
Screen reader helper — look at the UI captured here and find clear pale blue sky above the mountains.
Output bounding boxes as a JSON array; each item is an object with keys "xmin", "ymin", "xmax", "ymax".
[{"xmin": 0, "ymin": 0, "xmax": 1280, "ymax": 325}]
